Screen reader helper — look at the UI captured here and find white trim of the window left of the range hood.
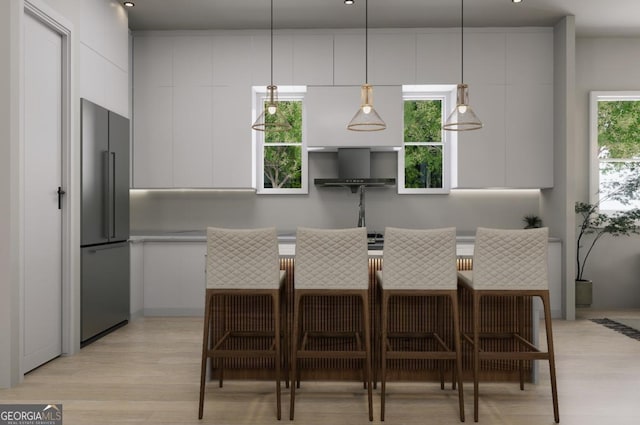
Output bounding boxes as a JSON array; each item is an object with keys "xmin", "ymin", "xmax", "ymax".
[{"xmin": 251, "ymin": 86, "xmax": 309, "ymax": 195}]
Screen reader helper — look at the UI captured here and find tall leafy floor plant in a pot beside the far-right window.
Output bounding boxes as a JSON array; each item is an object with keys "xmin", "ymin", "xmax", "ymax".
[{"xmin": 575, "ymin": 168, "xmax": 640, "ymax": 307}]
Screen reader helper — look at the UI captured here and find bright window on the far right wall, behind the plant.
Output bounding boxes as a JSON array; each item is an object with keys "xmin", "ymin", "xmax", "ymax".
[{"xmin": 590, "ymin": 92, "xmax": 640, "ymax": 212}]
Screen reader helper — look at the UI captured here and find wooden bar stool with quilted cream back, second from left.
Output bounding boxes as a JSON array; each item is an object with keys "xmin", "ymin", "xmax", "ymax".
[{"xmin": 289, "ymin": 227, "xmax": 373, "ymax": 421}]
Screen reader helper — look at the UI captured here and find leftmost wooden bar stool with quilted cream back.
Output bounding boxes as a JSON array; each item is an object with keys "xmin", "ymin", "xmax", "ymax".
[{"xmin": 198, "ymin": 227, "xmax": 286, "ymax": 419}]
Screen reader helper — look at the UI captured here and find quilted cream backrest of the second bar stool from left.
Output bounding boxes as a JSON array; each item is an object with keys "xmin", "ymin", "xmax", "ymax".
[{"xmin": 295, "ymin": 227, "xmax": 369, "ymax": 290}]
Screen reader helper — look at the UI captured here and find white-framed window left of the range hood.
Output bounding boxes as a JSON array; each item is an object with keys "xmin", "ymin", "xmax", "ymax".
[{"xmin": 253, "ymin": 87, "xmax": 308, "ymax": 194}]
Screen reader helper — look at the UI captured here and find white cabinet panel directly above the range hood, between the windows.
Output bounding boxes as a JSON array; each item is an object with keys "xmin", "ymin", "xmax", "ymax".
[{"xmin": 305, "ymin": 86, "xmax": 403, "ymax": 147}]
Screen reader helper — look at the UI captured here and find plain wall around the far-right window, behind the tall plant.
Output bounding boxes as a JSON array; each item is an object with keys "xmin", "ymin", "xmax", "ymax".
[{"xmin": 573, "ymin": 38, "xmax": 640, "ymax": 309}]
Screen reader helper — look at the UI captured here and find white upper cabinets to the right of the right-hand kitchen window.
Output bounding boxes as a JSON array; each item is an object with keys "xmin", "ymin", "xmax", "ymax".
[{"xmin": 458, "ymin": 30, "xmax": 554, "ymax": 189}]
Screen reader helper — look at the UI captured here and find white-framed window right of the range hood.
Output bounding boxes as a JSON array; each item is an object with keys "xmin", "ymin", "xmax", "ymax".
[{"xmin": 398, "ymin": 86, "xmax": 453, "ymax": 194}]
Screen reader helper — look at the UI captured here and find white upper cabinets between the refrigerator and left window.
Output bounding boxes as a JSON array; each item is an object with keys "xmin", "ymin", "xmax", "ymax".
[{"xmin": 133, "ymin": 33, "xmax": 252, "ymax": 188}]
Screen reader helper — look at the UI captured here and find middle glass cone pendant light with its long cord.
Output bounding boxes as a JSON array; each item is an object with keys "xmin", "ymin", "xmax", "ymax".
[{"xmin": 347, "ymin": 0, "xmax": 387, "ymax": 131}]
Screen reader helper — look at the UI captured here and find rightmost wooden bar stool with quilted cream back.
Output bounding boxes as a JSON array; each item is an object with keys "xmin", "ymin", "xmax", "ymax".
[{"xmin": 458, "ymin": 227, "xmax": 560, "ymax": 423}]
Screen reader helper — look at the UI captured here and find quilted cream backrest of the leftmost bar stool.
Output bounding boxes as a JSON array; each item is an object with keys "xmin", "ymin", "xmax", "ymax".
[{"xmin": 207, "ymin": 227, "xmax": 280, "ymax": 289}]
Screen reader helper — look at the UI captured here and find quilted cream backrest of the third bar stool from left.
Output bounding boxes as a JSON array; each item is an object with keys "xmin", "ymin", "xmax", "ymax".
[{"xmin": 382, "ymin": 227, "xmax": 457, "ymax": 290}]
